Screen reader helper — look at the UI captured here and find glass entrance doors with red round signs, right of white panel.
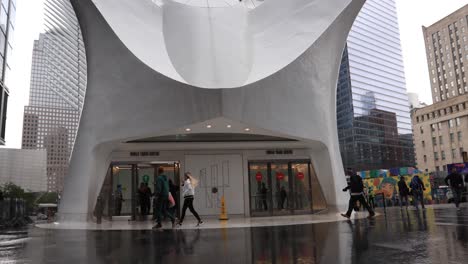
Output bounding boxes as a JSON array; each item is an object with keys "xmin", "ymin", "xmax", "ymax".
[{"xmin": 249, "ymin": 160, "xmax": 326, "ymax": 216}]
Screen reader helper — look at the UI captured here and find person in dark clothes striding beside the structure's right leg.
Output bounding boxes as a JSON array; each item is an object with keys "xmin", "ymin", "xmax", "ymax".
[{"xmin": 341, "ymin": 171, "xmax": 375, "ymax": 219}]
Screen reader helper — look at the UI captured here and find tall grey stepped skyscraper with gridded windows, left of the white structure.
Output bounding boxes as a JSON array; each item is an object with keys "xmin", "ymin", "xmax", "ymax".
[{"xmin": 22, "ymin": 0, "xmax": 87, "ymax": 192}]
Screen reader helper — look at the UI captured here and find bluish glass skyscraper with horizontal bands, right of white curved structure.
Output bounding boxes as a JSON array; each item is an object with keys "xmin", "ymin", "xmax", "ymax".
[{"xmin": 337, "ymin": 0, "xmax": 414, "ymax": 170}]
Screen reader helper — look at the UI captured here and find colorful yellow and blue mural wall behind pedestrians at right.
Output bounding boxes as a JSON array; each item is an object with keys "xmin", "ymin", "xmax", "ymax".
[{"xmin": 358, "ymin": 168, "xmax": 432, "ymax": 201}]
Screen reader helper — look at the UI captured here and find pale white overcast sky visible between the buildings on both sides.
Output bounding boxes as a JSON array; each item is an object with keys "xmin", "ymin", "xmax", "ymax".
[{"xmin": 0, "ymin": 0, "xmax": 467, "ymax": 148}]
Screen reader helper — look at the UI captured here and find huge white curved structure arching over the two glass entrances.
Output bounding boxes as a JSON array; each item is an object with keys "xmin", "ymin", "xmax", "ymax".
[{"xmin": 60, "ymin": 0, "xmax": 365, "ymax": 221}]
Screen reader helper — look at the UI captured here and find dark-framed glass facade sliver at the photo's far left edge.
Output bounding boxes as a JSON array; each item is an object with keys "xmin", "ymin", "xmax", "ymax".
[{"xmin": 0, "ymin": 0, "xmax": 16, "ymax": 145}]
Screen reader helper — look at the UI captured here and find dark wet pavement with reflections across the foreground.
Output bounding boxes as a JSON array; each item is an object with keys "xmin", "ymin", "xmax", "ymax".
[{"xmin": 0, "ymin": 208, "xmax": 468, "ymax": 264}]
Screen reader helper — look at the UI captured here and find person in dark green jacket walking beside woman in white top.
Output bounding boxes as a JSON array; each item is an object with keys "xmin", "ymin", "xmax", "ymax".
[{"xmin": 153, "ymin": 167, "xmax": 175, "ymax": 229}]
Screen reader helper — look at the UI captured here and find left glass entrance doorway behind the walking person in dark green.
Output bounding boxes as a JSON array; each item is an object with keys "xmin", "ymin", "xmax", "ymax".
[{"xmin": 101, "ymin": 161, "xmax": 180, "ymax": 220}]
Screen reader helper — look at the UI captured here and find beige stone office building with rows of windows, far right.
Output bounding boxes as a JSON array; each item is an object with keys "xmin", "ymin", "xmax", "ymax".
[{"xmin": 412, "ymin": 5, "xmax": 468, "ymax": 172}]
